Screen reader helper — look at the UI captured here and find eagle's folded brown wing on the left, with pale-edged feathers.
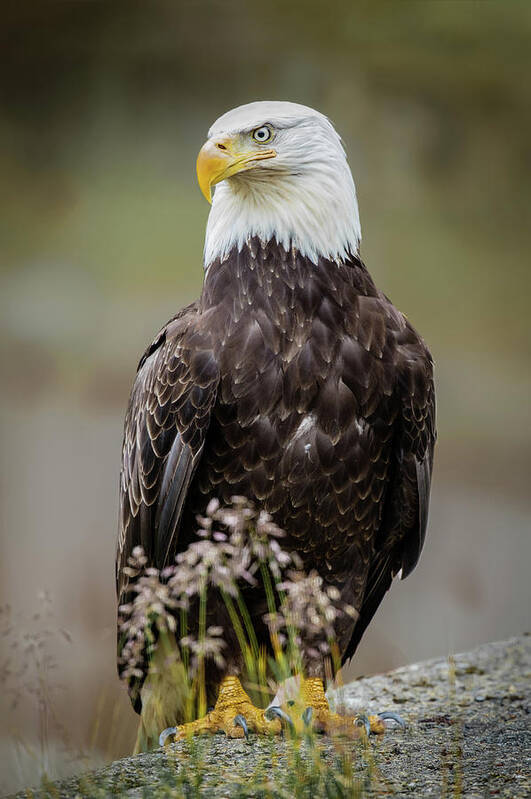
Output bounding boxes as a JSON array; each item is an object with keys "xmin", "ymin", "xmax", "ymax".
[{"xmin": 116, "ymin": 303, "xmax": 219, "ymax": 601}]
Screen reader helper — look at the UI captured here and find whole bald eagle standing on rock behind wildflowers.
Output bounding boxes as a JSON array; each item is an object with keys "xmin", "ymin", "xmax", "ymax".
[{"xmin": 116, "ymin": 102, "xmax": 435, "ymax": 752}]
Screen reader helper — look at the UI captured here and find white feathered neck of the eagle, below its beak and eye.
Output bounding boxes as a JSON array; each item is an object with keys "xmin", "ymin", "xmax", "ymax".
[{"xmin": 204, "ymin": 148, "xmax": 361, "ymax": 269}]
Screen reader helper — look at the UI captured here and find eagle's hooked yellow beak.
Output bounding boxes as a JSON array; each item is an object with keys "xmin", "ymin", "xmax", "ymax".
[{"xmin": 197, "ymin": 134, "xmax": 276, "ymax": 203}]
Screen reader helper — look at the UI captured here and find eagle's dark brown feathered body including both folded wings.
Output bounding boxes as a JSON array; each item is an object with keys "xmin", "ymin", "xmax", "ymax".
[{"xmin": 117, "ymin": 239, "xmax": 435, "ymax": 709}]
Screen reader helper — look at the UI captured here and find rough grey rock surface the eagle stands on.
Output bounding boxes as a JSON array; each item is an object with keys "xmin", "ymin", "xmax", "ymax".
[{"xmin": 10, "ymin": 636, "xmax": 531, "ymax": 799}]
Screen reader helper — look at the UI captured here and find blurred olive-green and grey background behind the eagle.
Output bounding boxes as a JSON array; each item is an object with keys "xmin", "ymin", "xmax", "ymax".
[{"xmin": 0, "ymin": 0, "xmax": 531, "ymax": 789}]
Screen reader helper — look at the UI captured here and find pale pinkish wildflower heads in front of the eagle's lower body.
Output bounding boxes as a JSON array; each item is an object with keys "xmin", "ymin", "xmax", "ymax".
[{"xmin": 119, "ymin": 496, "xmax": 356, "ymax": 678}]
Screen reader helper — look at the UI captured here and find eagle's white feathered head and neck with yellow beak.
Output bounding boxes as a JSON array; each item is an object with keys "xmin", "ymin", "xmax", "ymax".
[{"xmin": 197, "ymin": 101, "xmax": 361, "ymax": 268}]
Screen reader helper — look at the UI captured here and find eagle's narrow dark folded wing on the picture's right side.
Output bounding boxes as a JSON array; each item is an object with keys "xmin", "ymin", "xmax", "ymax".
[{"xmin": 343, "ymin": 323, "xmax": 436, "ymax": 660}]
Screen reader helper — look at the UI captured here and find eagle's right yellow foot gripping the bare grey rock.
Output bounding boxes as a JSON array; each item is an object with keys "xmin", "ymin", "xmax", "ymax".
[{"xmin": 286, "ymin": 677, "xmax": 404, "ymax": 738}]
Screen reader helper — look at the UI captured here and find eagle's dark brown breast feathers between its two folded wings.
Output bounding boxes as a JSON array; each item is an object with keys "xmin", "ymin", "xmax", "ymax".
[{"xmin": 189, "ymin": 245, "xmax": 393, "ymax": 579}]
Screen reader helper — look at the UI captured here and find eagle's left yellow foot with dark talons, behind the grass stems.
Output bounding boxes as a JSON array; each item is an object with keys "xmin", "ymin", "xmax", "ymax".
[{"xmin": 159, "ymin": 677, "xmax": 281, "ymax": 746}]
